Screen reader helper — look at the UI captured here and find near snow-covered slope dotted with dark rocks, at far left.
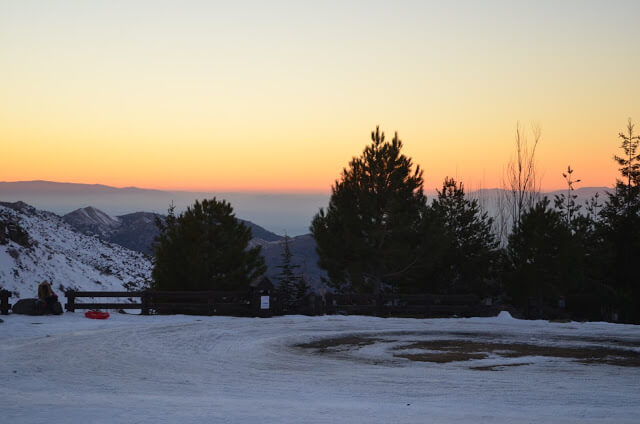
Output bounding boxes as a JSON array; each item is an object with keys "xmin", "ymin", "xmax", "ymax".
[{"xmin": 0, "ymin": 202, "xmax": 152, "ymax": 298}]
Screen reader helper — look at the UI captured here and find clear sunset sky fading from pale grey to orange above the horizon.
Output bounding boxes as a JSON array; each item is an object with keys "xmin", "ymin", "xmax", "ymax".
[{"xmin": 0, "ymin": 0, "xmax": 640, "ymax": 191}]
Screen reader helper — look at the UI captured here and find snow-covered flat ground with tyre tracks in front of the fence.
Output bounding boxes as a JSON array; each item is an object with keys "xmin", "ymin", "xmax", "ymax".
[{"xmin": 0, "ymin": 312, "xmax": 640, "ymax": 424}]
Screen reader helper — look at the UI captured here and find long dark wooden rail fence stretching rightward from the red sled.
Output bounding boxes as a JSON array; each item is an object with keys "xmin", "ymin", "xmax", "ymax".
[{"xmin": 65, "ymin": 290, "xmax": 484, "ymax": 317}]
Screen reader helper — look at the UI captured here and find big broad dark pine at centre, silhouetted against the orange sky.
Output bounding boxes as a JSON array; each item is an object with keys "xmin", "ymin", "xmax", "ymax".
[{"xmin": 311, "ymin": 128, "xmax": 426, "ymax": 294}]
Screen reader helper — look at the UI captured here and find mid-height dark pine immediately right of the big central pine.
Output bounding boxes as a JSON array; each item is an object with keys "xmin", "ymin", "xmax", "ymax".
[{"xmin": 431, "ymin": 178, "xmax": 498, "ymax": 294}]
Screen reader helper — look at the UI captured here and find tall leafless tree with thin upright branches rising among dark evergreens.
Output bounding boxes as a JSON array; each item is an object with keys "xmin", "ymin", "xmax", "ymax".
[{"xmin": 498, "ymin": 122, "xmax": 542, "ymax": 239}]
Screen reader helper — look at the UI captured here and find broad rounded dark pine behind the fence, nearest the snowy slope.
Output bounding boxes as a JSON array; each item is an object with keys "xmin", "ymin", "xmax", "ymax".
[{"xmin": 152, "ymin": 198, "xmax": 266, "ymax": 291}]
